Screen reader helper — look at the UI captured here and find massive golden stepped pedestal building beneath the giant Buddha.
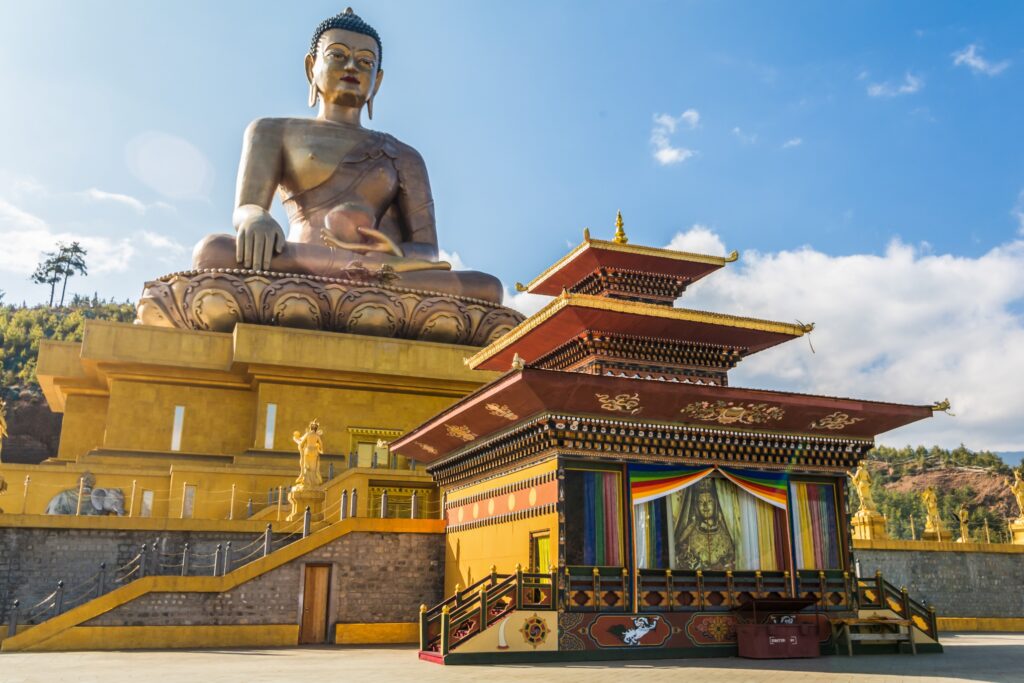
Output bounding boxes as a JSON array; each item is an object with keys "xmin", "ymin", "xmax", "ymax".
[{"xmin": 0, "ymin": 322, "xmax": 496, "ymax": 519}]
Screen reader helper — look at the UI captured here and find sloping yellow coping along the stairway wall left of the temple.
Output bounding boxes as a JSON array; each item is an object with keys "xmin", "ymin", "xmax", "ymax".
[{"xmin": 0, "ymin": 517, "xmax": 444, "ymax": 652}]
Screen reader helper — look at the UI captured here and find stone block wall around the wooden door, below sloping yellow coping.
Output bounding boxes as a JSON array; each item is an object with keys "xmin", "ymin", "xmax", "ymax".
[{"xmin": 82, "ymin": 531, "xmax": 444, "ymax": 633}]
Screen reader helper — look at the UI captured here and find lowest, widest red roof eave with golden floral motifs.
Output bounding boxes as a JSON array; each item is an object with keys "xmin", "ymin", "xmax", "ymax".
[{"xmin": 391, "ymin": 368, "xmax": 934, "ymax": 463}]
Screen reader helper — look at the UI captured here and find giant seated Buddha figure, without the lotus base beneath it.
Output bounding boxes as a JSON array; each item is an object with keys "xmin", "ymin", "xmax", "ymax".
[{"xmin": 193, "ymin": 8, "xmax": 502, "ymax": 303}]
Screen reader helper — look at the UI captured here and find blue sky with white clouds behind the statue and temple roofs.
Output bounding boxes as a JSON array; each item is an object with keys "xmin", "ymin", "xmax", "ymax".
[{"xmin": 0, "ymin": 0, "xmax": 1024, "ymax": 450}]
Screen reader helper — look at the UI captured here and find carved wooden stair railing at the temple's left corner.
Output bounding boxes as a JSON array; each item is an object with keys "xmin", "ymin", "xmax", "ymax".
[{"xmin": 420, "ymin": 567, "xmax": 558, "ymax": 656}]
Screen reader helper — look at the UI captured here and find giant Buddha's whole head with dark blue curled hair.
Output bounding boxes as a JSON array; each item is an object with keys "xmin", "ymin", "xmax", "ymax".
[{"xmin": 306, "ymin": 7, "xmax": 384, "ymax": 119}]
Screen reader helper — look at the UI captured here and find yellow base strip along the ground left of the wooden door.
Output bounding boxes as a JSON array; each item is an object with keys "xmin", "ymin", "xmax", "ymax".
[{"xmin": 12, "ymin": 624, "xmax": 299, "ymax": 652}]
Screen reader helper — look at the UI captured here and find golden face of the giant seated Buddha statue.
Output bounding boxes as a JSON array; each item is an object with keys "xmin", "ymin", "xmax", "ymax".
[{"xmin": 306, "ymin": 29, "xmax": 384, "ymax": 106}]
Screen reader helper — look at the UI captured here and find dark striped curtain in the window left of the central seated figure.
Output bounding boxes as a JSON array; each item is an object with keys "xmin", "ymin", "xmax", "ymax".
[{"xmin": 585, "ymin": 471, "xmax": 625, "ymax": 566}]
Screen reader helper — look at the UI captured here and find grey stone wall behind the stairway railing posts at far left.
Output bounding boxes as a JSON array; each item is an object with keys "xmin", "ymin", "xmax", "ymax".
[{"xmin": 0, "ymin": 527, "xmax": 284, "ymax": 624}]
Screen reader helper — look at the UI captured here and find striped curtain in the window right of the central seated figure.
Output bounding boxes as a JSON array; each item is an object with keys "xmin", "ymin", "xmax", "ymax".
[{"xmin": 790, "ymin": 481, "xmax": 842, "ymax": 569}]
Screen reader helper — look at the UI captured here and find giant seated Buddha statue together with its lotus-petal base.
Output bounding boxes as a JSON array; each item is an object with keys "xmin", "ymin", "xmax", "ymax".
[{"xmin": 138, "ymin": 8, "xmax": 520, "ymax": 344}]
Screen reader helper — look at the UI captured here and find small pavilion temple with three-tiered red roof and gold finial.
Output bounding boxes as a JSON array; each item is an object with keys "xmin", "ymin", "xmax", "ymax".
[{"xmin": 391, "ymin": 216, "xmax": 937, "ymax": 664}]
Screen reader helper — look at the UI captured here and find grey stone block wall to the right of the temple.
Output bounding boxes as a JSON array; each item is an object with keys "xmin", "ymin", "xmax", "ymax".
[{"xmin": 854, "ymin": 549, "xmax": 1024, "ymax": 617}]
